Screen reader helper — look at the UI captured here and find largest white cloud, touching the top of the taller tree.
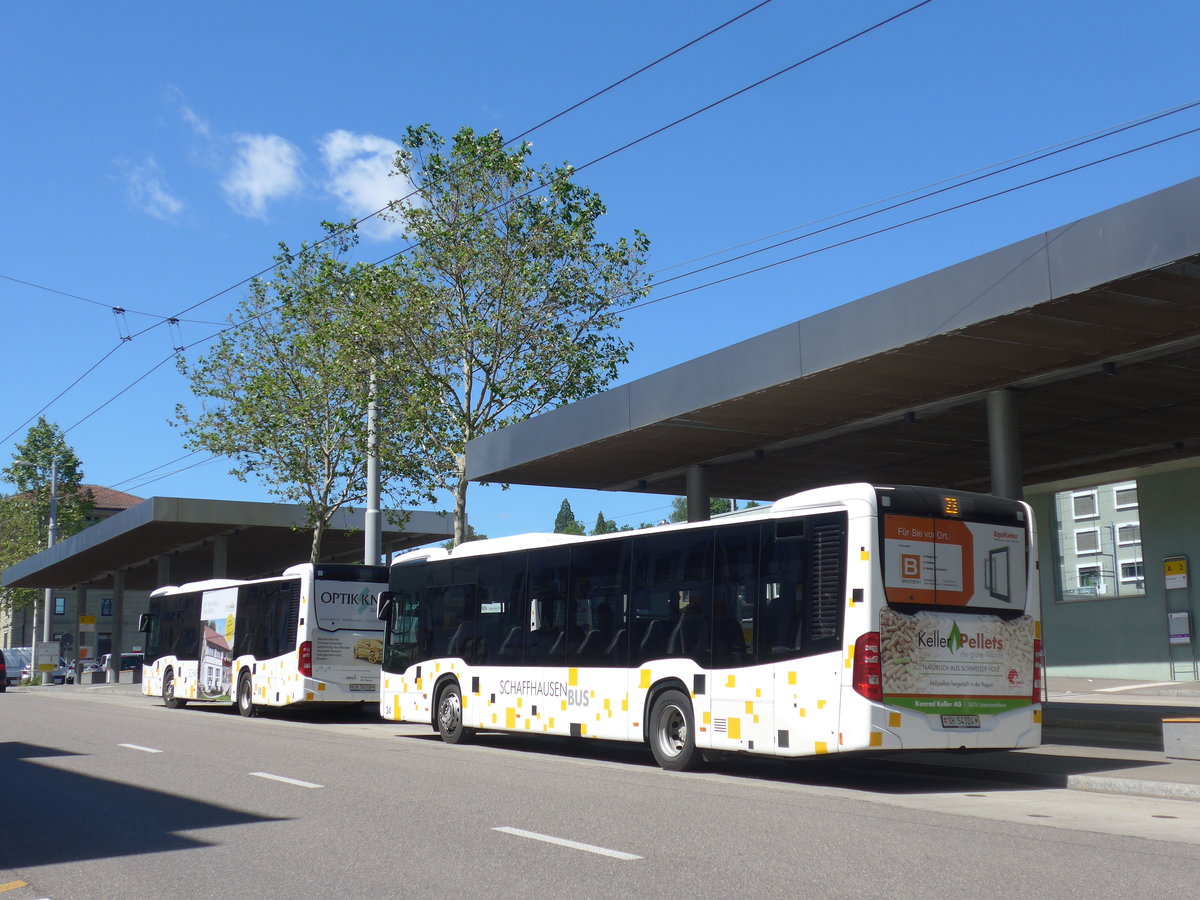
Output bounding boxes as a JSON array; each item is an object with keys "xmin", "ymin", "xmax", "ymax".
[{"xmin": 320, "ymin": 128, "xmax": 412, "ymax": 240}]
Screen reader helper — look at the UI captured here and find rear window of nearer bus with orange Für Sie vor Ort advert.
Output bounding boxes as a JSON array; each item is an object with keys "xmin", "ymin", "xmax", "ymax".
[{"xmin": 882, "ymin": 514, "xmax": 1027, "ymax": 612}]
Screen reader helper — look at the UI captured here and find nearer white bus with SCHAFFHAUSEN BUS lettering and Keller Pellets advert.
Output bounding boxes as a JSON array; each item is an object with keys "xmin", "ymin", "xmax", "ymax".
[{"xmin": 379, "ymin": 484, "xmax": 1042, "ymax": 769}]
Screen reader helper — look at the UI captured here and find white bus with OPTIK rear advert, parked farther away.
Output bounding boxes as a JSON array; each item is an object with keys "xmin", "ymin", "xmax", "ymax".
[{"xmin": 139, "ymin": 563, "xmax": 388, "ymax": 716}]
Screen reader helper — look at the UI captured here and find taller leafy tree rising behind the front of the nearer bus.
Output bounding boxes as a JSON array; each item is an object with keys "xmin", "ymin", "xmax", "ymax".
[{"xmin": 377, "ymin": 126, "xmax": 649, "ymax": 542}]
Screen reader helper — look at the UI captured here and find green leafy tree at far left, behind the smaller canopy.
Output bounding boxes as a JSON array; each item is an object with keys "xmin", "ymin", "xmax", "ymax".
[{"xmin": 0, "ymin": 418, "xmax": 94, "ymax": 611}]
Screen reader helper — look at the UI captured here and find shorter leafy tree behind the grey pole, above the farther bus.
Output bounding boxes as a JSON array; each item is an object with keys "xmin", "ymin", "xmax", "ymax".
[{"xmin": 176, "ymin": 222, "xmax": 427, "ymax": 562}]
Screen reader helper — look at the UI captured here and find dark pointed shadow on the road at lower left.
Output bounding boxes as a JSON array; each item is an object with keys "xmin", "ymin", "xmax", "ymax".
[{"xmin": 0, "ymin": 742, "xmax": 278, "ymax": 870}]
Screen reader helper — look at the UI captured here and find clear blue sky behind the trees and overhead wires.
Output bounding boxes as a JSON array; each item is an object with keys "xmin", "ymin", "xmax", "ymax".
[{"xmin": 0, "ymin": 0, "xmax": 1200, "ymax": 536}]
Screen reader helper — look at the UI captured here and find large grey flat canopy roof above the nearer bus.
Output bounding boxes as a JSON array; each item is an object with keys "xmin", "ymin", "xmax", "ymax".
[{"xmin": 467, "ymin": 179, "xmax": 1200, "ymax": 499}]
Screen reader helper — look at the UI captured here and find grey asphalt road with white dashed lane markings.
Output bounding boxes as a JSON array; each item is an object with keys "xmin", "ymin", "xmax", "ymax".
[{"xmin": 0, "ymin": 689, "xmax": 1200, "ymax": 900}]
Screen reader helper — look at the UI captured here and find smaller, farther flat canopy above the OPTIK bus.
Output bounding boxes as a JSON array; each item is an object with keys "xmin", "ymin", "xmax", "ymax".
[{"xmin": 4, "ymin": 497, "xmax": 454, "ymax": 590}]
